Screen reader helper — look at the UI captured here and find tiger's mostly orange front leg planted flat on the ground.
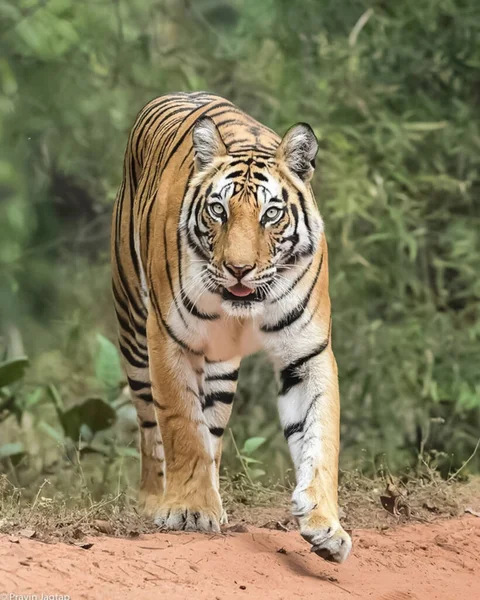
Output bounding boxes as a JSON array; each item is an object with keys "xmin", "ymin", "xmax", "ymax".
[{"xmin": 147, "ymin": 322, "xmax": 222, "ymax": 531}]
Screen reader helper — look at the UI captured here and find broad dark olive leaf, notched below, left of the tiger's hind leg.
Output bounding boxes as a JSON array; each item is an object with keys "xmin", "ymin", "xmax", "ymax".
[{"xmin": 60, "ymin": 398, "xmax": 116, "ymax": 442}]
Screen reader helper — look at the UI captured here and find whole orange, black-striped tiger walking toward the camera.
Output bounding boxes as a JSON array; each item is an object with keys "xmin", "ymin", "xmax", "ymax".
[{"xmin": 111, "ymin": 92, "xmax": 352, "ymax": 563}]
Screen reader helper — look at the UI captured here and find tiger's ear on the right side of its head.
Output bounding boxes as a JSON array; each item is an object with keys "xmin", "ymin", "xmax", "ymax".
[{"xmin": 277, "ymin": 123, "xmax": 318, "ymax": 183}]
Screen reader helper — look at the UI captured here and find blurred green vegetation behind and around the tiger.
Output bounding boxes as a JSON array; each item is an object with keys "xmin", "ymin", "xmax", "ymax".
[{"xmin": 0, "ymin": 0, "xmax": 480, "ymax": 496}]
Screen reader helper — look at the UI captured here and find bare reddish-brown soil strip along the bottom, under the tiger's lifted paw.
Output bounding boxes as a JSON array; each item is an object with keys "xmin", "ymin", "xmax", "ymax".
[{"xmin": 0, "ymin": 516, "xmax": 480, "ymax": 600}]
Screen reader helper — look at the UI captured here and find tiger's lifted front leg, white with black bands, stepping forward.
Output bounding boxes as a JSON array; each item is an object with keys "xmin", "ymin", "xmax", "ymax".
[{"xmin": 279, "ymin": 339, "xmax": 352, "ymax": 562}]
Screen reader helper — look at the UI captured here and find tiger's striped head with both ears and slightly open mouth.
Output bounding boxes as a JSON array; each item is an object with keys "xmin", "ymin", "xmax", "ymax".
[{"xmin": 182, "ymin": 117, "xmax": 323, "ymax": 317}]
